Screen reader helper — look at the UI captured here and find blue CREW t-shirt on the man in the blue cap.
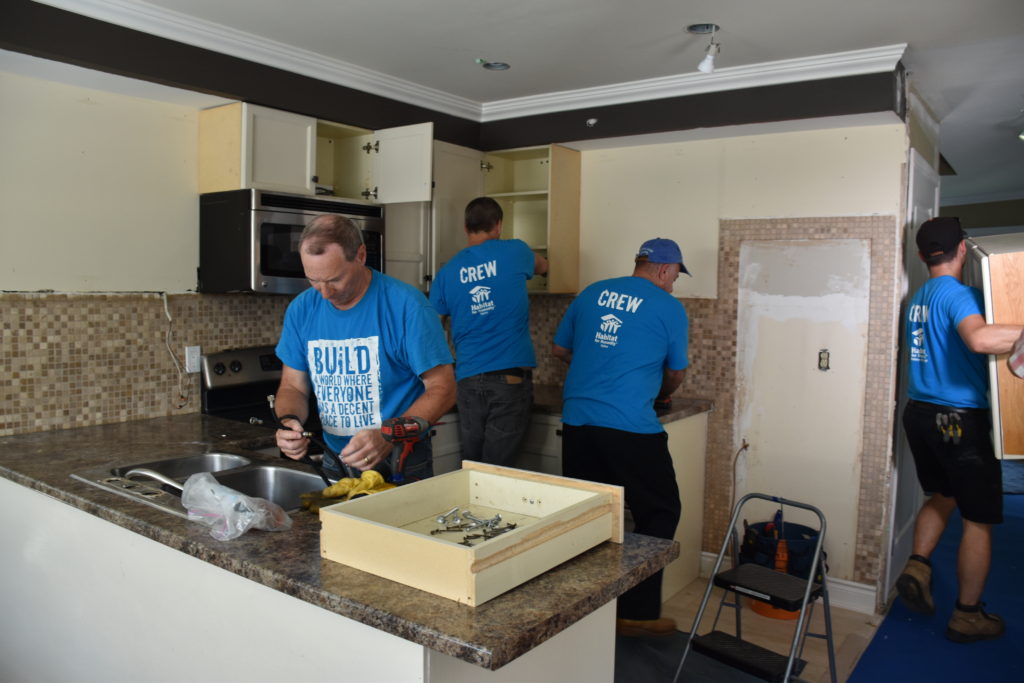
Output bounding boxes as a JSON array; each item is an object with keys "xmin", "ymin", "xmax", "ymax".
[{"xmin": 555, "ymin": 276, "xmax": 689, "ymax": 434}]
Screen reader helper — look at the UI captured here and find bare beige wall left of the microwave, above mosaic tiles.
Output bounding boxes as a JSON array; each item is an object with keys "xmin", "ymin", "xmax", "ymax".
[{"xmin": 0, "ymin": 72, "xmax": 199, "ymax": 292}]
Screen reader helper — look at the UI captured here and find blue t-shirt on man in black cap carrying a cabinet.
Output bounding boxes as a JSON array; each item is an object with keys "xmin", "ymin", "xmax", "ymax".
[{"xmin": 906, "ymin": 275, "xmax": 988, "ymax": 409}]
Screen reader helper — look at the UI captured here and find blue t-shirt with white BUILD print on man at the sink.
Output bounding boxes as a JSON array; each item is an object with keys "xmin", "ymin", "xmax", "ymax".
[{"xmin": 276, "ymin": 270, "xmax": 452, "ymax": 453}]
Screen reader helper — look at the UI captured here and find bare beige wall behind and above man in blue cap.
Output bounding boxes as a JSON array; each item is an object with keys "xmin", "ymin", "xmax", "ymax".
[{"xmin": 580, "ymin": 124, "xmax": 906, "ymax": 298}]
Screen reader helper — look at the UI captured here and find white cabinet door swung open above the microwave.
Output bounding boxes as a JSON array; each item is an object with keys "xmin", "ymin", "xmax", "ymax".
[{"xmin": 374, "ymin": 123, "xmax": 434, "ymax": 204}]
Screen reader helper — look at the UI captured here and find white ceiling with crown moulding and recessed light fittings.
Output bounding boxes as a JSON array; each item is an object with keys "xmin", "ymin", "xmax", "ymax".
[{"xmin": 24, "ymin": 0, "xmax": 1024, "ymax": 205}]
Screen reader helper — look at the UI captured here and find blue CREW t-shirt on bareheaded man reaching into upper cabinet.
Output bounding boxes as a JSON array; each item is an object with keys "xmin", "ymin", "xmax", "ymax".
[{"xmin": 430, "ymin": 240, "xmax": 537, "ymax": 380}]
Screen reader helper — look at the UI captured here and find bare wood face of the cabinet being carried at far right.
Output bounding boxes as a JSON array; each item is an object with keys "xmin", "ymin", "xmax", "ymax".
[{"xmin": 988, "ymin": 252, "xmax": 1024, "ymax": 456}]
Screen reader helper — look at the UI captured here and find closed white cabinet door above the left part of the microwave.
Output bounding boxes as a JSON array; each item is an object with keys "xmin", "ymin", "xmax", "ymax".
[{"xmin": 242, "ymin": 103, "xmax": 316, "ymax": 195}]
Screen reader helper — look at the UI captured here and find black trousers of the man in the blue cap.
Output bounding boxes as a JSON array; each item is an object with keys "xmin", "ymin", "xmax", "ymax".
[{"xmin": 562, "ymin": 425, "xmax": 683, "ymax": 620}]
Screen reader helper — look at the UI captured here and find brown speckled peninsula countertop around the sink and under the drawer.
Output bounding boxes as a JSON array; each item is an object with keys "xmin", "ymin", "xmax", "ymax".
[{"xmin": 0, "ymin": 415, "xmax": 679, "ymax": 670}]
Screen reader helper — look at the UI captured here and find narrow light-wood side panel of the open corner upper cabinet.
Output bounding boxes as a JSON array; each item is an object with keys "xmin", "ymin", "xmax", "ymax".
[{"xmin": 548, "ymin": 144, "xmax": 581, "ymax": 294}]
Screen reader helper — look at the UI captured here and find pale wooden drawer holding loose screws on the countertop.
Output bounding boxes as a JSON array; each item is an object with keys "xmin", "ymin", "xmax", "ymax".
[{"xmin": 319, "ymin": 461, "xmax": 623, "ymax": 605}]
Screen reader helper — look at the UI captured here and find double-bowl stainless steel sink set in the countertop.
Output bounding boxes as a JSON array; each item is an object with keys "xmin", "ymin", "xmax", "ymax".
[{"xmin": 71, "ymin": 453, "xmax": 324, "ymax": 518}]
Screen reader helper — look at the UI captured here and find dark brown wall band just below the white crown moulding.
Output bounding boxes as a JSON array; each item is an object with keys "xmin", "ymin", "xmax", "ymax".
[{"xmin": 6, "ymin": 0, "xmax": 904, "ymax": 150}]
